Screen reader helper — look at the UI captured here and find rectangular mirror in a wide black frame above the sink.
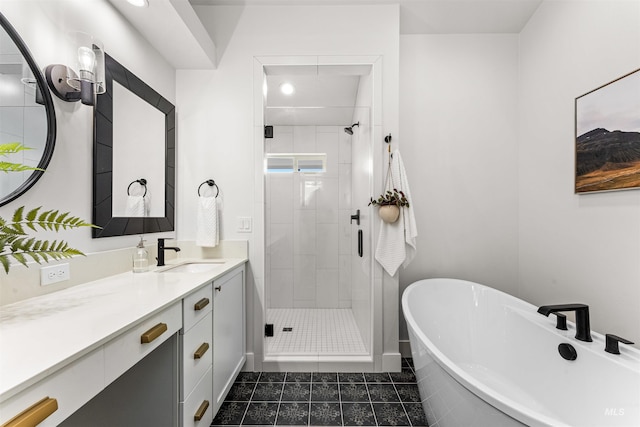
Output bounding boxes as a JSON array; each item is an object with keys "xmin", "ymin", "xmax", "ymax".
[{"xmin": 93, "ymin": 54, "xmax": 176, "ymax": 238}]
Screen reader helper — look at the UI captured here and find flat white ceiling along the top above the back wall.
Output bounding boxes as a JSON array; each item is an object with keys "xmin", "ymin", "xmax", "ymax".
[{"xmin": 189, "ymin": 0, "xmax": 543, "ymax": 34}]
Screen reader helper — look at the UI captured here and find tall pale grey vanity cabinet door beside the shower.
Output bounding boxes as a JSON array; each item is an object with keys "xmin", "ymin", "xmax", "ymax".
[{"xmin": 213, "ymin": 265, "xmax": 246, "ymax": 414}]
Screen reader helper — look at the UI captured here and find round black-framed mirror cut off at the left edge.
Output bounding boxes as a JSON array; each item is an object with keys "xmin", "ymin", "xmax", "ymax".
[{"xmin": 0, "ymin": 13, "xmax": 56, "ymax": 206}]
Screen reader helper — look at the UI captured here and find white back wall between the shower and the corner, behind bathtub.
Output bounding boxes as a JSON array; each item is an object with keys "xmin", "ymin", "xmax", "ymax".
[{"xmin": 399, "ymin": 34, "xmax": 518, "ymax": 339}]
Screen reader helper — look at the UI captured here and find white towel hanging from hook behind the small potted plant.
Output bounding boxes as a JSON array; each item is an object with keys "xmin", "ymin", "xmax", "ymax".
[{"xmin": 376, "ymin": 150, "xmax": 418, "ymax": 276}]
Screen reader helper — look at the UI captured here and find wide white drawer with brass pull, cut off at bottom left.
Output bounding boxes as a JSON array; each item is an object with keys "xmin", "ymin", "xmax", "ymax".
[{"xmin": 0, "ymin": 343, "xmax": 104, "ymax": 427}]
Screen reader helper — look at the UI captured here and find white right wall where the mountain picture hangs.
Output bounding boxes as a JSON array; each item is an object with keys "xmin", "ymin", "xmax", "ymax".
[{"xmin": 518, "ymin": 0, "xmax": 640, "ymax": 343}]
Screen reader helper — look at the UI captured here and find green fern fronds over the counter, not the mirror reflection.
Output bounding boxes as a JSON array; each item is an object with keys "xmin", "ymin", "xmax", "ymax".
[{"xmin": 0, "ymin": 206, "xmax": 94, "ymax": 273}]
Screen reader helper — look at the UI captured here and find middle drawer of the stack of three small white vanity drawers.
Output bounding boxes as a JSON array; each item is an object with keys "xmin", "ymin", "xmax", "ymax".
[{"xmin": 181, "ymin": 312, "xmax": 213, "ymax": 400}]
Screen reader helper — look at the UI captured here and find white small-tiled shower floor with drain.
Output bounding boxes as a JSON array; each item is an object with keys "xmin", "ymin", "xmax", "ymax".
[{"xmin": 265, "ymin": 308, "xmax": 368, "ymax": 355}]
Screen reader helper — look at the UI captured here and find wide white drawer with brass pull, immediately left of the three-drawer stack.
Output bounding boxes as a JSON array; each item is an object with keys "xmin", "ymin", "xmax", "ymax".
[{"xmin": 104, "ymin": 302, "xmax": 182, "ymax": 384}]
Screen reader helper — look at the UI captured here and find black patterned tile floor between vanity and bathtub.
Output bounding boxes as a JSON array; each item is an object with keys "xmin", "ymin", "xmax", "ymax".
[{"xmin": 212, "ymin": 359, "xmax": 427, "ymax": 427}]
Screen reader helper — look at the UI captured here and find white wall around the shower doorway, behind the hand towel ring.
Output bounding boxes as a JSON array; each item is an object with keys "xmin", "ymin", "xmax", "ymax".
[{"xmin": 177, "ymin": 5, "xmax": 399, "ymax": 372}]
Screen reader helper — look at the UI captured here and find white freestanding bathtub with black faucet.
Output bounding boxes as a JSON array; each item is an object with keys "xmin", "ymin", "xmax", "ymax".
[{"xmin": 402, "ymin": 279, "xmax": 640, "ymax": 427}]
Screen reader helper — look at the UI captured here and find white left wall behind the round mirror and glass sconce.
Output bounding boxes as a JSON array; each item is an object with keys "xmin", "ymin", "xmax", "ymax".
[{"xmin": 0, "ymin": 0, "xmax": 175, "ymax": 253}]
